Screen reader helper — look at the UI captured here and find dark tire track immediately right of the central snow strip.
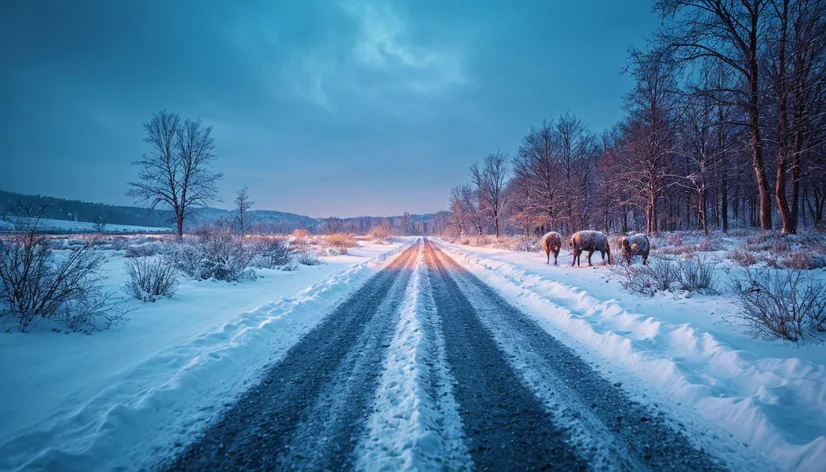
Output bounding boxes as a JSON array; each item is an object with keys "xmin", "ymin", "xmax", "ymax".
[{"xmin": 418, "ymin": 242, "xmax": 586, "ymax": 470}]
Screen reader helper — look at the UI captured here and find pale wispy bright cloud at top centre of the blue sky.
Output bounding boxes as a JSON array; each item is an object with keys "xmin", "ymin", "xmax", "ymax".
[{"xmin": 284, "ymin": 0, "xmax": 468, "ymax": 115}]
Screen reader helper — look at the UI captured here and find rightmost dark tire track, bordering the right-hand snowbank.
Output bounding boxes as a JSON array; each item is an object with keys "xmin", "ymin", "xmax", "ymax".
[{"xmin": 427, "ymin": 243, "xmax": 722, "ymax": 470}]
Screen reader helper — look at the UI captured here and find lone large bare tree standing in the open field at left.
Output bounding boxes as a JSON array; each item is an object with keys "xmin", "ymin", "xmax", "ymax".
[{"xmin": 127, "ymin": 111, "xmax": 222, "ymax": 238}]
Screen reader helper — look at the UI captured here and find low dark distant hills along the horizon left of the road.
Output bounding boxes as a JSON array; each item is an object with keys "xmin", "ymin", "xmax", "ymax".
[{"xmin": 0, "ymin": 190, "xmax": 435, "ymax": 234}]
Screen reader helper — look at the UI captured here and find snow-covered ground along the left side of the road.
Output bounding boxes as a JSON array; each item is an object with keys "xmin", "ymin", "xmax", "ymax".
[{"xmin": 0, "ymin": 244, "xmax": 403, "ymax": 470}]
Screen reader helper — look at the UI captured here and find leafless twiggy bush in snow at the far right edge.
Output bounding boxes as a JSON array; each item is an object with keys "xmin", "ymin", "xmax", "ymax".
[{"xmin": 732, "ymin": 269, "xmax": 826, "ymax": 343}]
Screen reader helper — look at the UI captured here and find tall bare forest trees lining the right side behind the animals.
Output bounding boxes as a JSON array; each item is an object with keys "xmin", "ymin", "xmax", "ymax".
[{"xmin": 449, "ymin": 0, "xmax": 826, "ymax": 236}]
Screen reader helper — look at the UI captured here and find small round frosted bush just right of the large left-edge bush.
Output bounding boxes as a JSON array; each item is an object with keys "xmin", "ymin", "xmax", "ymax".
[{"xmin": 121, "ymin": 257, "xmax": 178, "ymax": 302}]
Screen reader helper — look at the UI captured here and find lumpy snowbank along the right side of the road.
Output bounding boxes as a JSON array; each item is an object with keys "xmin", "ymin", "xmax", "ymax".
[{"xmin": 434, "ymin": 243, "xmax": 826, "ymax": 470}]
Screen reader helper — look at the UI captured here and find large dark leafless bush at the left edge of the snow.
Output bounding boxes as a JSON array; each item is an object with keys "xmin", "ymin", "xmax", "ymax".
[{"xmin": 0, "ymin": 229, "xmax": 124, "ymax": 332}]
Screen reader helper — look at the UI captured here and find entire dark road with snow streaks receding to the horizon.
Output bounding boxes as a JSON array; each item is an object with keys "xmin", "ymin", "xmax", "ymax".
[{"xmin": 168, "ymin": 241, "xmax": 722, "ymax": 470}]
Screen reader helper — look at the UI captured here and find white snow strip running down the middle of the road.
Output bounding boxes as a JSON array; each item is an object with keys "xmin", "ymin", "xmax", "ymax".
[{"xmin": 356, "ymin": 242, "xmax": 470, "ymax": 470}]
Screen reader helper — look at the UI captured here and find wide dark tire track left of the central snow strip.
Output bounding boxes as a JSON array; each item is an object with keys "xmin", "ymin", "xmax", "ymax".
[{"xmin": 168, "ymin": 243, "xmax": 419, "ymax": 470}]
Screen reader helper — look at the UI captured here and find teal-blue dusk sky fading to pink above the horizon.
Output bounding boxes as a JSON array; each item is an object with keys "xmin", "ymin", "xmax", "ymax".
[{"xmin": 0, "ymin": 0, "xmax": 659, "ymax": 217}]
